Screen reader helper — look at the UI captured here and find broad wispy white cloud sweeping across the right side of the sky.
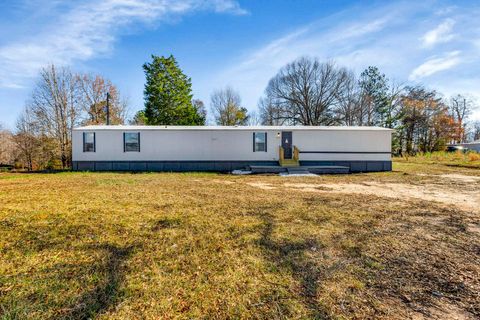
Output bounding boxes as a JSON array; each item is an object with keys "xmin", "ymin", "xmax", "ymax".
[{"xmin": 202, "ymin": 2, "xmax": 480, "ymax": 115}]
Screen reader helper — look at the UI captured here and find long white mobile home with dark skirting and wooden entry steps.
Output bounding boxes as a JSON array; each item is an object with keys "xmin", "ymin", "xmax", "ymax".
[{"xmin": 73, "ymin": 125, "xmax": 392, "ymax": 172}]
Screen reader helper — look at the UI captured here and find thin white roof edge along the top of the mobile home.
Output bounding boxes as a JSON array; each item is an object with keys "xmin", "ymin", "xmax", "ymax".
[{"xmin": 73, "ymin": 125, "xmax": 392, "ymax": 131}]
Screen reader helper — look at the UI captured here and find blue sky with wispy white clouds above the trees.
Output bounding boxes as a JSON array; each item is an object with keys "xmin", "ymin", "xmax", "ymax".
[{"xmin": 0, "ymin": 0, "xmax": 480, "ymax": 128}]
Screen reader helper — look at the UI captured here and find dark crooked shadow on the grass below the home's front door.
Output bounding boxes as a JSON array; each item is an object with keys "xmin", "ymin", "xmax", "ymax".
[{"xmin": 259, "ymin": 213, "xmax": 330, "ymax": 319}]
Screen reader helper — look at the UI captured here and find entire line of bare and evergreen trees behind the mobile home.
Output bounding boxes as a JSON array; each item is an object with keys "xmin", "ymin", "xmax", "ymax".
[{"xmin": 0, "ymin": 55, "xmax": 480, "ymax": 170}]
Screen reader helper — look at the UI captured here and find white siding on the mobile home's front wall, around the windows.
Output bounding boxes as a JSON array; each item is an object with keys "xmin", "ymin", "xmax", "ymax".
[{"xmin": 73, "ymin": 126, "xmax": 391, "ymax": 161}]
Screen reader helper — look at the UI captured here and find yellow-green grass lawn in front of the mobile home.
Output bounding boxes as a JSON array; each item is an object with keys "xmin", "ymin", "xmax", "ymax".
[{"xmin": 0, "ymin": 159, "xmax": 480, "ymax": 319}]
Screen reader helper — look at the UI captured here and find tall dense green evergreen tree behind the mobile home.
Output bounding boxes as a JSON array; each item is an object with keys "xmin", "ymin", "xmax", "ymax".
[{"xmin": 143, "ymin": 55, "xmax": 205, "ymax": 125}]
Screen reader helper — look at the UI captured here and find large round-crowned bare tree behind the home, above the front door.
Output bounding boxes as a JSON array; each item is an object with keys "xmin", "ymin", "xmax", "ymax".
[{"xmin": 265, "ymin": 57, "xmax": 350, "ymax": 125}]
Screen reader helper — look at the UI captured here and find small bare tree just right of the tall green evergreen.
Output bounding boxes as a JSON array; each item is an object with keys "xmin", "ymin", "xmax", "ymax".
[{"xmin": 210, "ymin": 87, "xmax": 248, "ymax": 126}]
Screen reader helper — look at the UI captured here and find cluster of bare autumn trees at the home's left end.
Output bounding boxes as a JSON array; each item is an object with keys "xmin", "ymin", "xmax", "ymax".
[{"xmin": 0, "ymin": 65, "xmax": 127, "ymax": 170}]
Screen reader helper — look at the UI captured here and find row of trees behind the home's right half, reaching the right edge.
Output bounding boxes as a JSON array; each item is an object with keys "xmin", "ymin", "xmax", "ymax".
[{"xmin": 259, "ymin": 58, "xmax": 480, "ymax": 154}]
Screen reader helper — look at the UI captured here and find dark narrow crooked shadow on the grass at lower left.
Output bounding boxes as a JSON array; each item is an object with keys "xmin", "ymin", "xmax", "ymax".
[{"xmin": 54, "ymin": 244, "xmax": 135, "ymax": 319}]
